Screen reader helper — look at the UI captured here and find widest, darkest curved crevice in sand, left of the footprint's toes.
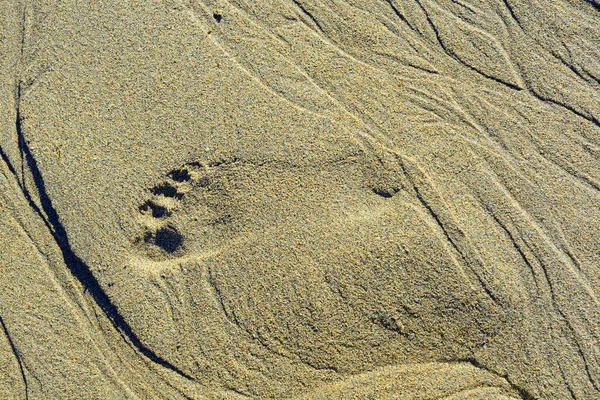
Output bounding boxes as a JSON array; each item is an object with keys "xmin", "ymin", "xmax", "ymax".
[{"xmin": 12, "ymin": 100, "xmax": 193, "ymax": 380}]
